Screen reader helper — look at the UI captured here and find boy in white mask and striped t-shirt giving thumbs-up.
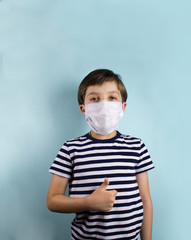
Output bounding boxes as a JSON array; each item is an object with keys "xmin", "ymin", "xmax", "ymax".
[{"xmin": 47, "ymin": 69, "xmax": 154, "ymax": 240}]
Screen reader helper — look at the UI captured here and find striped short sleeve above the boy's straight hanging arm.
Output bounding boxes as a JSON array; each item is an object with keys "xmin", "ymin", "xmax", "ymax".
[{"xmin": 135, "ymin": 140, "xmax": 154, "ymax": 174}]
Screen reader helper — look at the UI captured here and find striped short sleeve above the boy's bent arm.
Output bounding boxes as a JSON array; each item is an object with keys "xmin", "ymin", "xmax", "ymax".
[{"xmin": 49, "ymin": 143, "xmax": 73, "ymax": 178}]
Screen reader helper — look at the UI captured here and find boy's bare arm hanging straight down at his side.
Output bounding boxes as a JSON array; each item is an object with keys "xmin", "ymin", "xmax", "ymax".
[{"xmin": 136, "ymin": 172, "xmax": 153, "ymax": 240}]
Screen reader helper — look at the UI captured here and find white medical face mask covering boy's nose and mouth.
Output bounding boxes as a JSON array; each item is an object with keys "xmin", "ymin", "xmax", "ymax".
[{"xmin": 85, "ymin": 100, "xmax": 123, "ymax": 135}]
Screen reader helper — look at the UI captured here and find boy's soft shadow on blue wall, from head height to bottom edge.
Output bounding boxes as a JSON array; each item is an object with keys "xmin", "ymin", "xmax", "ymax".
[{"xmin": 33, "ymin": 81, "xmax": 86, "ymax": 240}]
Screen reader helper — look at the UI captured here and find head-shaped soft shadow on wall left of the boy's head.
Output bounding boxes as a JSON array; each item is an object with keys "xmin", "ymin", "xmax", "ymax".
[{"xmin": 50, "ymin": 83, "xmax": 86, "ymax": 143}]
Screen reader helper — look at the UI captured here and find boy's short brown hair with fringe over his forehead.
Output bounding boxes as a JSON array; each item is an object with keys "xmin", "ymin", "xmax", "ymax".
[{"xmin": 78, "ymin": 69, "xmax": 127, "ymax": 105}]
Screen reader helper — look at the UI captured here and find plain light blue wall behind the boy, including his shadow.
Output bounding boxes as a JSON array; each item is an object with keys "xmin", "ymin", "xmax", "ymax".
[{"xmin": 0, "ymin": 0, "xmax": 191, "ymax": 240}]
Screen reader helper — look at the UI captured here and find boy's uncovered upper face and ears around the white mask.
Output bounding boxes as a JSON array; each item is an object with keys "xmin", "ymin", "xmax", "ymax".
[{"xmin": 80, "ymin": 81, "xmax": 127, "ymax": 116}]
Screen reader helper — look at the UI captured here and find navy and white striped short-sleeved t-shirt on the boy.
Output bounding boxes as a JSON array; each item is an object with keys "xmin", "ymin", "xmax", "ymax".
[{"xmin": 49, "ymin": 132, "xmax": 154, "ymax": 240}]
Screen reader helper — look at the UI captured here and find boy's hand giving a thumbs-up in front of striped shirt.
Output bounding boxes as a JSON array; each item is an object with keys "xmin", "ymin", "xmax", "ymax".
[{"xmin": 88, "ymin": 178, "xmax": 117, "ymax": 211}]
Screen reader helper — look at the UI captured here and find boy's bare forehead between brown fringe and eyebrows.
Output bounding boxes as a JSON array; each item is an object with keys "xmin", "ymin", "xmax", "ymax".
[{"xmin": 86, "ymin": 81, "xmax": 120, "ymax": 96}]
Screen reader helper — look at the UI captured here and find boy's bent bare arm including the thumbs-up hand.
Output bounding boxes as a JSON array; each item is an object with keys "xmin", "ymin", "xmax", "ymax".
[{"xmin": 47, "ymin": 175, "xmax": 117, "ymax": 213}]
